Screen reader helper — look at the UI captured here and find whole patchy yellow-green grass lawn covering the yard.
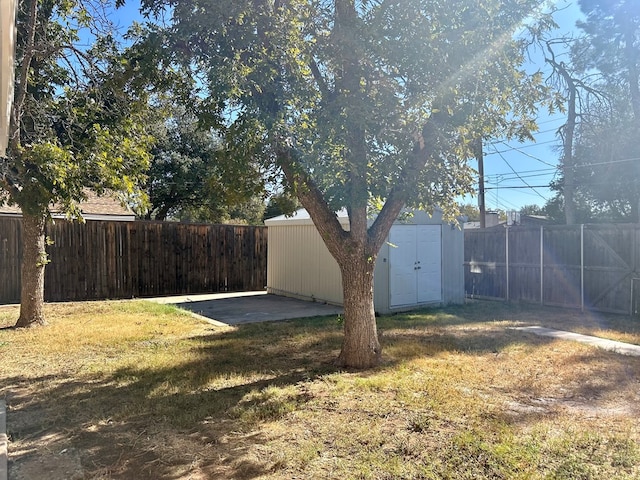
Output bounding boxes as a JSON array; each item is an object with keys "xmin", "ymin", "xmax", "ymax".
[{"xmin": 0, "ymin": 301, "xmax": 640, "ymax": 480}]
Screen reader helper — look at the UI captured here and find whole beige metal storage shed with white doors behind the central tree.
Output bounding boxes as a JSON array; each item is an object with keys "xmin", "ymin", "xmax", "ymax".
[{"xmin": 265, "ymin": 209, "xmax": 464, "ymax": 314}]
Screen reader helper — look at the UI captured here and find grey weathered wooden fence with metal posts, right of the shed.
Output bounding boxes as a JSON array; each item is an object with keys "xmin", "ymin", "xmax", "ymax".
[{"xmin": 464, "ymin": 224, "xmax": 640, "ymax": 315}]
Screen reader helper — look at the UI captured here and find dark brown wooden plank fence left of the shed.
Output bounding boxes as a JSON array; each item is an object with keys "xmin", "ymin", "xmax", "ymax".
[{"xmin": 0, "ymin": 218, "xmax": 267, "ymax": 304}]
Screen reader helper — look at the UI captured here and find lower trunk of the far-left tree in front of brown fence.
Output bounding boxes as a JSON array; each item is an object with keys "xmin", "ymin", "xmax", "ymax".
[{"xmin": 16, "ymin": 215, "xmax": 47, "ymax": 327}]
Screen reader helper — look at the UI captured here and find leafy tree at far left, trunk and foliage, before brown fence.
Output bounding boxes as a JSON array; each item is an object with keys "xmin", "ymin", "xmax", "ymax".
[{"xmin": 0, "ymin": 0, "xmax": 150, "ymax": 327}]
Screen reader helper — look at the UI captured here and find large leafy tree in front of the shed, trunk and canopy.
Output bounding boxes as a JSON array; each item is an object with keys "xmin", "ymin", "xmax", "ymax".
[{"xmin": 143, "ymin": 0, "xmax": 544, "ymax": 368}]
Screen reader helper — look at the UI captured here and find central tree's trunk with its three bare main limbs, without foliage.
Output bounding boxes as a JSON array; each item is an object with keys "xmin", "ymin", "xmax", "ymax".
[{"xmin": 275, "ymin": 0, "xmax": 448, "ymax": 369}]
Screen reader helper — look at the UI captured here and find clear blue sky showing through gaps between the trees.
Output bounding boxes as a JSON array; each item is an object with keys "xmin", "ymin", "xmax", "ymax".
[{"xmin": 112, "ymin": 0, "xmax": 582, "ymax": 211}]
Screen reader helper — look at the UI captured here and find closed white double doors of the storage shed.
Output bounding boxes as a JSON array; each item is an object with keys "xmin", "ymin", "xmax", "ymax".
[{"xmin": 389, "ymin": 225, "xmax": 442, "ymax": 307}]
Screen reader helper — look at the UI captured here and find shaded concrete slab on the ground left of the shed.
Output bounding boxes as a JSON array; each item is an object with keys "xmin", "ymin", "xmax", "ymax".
[{"xmin": 146, "ymin": 291, "xmax": 343, "ymax": 325}]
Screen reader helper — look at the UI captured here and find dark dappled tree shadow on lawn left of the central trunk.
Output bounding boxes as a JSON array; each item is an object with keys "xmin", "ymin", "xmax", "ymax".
[{"xmin": 4, "ymin": 318, "xmax": 340, "ymax": 480}]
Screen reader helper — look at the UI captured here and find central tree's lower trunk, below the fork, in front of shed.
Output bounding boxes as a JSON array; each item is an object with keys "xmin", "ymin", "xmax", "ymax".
[{"xmin": 337, "ymin": 256, "xmax": 382, "ymax": 368}]
